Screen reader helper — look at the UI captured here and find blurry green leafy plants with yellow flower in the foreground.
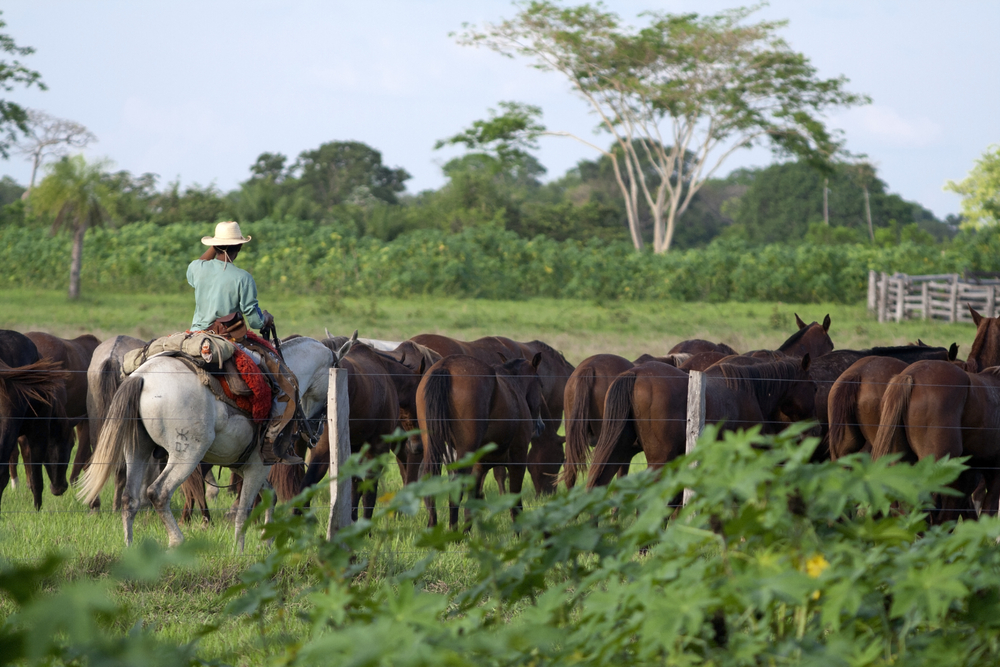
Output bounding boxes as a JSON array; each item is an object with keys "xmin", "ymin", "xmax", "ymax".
[{"xmin": 7, "ymin": 427, "xmax": 1000, "ymax": 665}]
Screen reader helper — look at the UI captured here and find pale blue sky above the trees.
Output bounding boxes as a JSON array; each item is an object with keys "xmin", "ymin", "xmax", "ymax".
[{"xmin": 0, "ymin": 0, "xmax": 1000, "ymax": 217}]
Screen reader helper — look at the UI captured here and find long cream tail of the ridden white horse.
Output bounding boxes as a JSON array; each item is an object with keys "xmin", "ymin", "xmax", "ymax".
[{"xmin": 76, "ymin": 375, "xmax": 145, "ymax": 505}]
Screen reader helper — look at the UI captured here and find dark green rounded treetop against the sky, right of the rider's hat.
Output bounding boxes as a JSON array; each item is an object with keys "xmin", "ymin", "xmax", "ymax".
[{"xmin": 296, "ymin": 141, "xmax": 410, "ymax": 209}]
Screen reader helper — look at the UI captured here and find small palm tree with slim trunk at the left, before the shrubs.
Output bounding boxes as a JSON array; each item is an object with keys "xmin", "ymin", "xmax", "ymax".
[{"xmin": 31, "ymin": 155, "xmax": 117, "ymax": 299}]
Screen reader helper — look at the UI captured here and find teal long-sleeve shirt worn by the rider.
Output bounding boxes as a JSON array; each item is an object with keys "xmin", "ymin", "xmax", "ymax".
[{"xmin": 187, "ymin": 259, "xmax": 264, "ymax": 331}]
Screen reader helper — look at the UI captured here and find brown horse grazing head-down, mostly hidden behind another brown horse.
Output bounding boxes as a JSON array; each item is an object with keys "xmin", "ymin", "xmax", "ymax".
[{"xmin": 410, "ymin": 334, "xmax": 573, "ymax": 494}]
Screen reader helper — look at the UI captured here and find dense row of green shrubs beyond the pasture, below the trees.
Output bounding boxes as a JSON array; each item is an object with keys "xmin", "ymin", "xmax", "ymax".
[{"xmin": 0, "ymin": 220, "xmax": 1000, "ymax": 303}]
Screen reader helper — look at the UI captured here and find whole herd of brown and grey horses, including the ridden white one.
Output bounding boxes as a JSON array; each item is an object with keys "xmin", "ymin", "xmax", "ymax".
[{"xmin": 0, "ymin": 308, "xmax": 1000, "ymax": 548}]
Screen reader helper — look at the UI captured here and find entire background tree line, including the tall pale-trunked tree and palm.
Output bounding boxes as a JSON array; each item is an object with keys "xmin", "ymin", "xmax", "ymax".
[{"xmin": 0, "ymin": 0, "xmax": 1000, "ymax": 296}]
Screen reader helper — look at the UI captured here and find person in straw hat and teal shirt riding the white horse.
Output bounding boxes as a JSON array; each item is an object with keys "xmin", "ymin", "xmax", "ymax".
[{"xmin": 187, "ymin": 222, "xmax": 303, "ymax": 463}]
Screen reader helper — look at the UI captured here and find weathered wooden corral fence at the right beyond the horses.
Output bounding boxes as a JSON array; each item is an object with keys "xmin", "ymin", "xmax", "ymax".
[{"xmin": 868, "ymin": 271, "xmax": 1000, "ymax": 322}]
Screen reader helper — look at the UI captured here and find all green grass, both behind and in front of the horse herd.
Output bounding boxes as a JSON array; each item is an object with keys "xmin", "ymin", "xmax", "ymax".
[{"xmin": 0, "ymin": 290, "xmax": 975, "ymax": 664}]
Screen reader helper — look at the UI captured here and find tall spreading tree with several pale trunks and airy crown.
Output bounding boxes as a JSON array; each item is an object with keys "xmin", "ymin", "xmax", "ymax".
[{"xmin": 459, "ymin": 0, "xmax": 867, "ymax": 252}]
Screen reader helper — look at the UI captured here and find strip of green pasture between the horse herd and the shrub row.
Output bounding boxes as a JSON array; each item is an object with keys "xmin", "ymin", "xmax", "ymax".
[{"xmin": 0, "ymin": 288, "xmax": 975, "ymax": 363}]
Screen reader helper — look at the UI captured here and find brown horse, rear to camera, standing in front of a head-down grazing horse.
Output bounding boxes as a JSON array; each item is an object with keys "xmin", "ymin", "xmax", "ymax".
[{"xmin": 417, "ymin": 354, "xmax": 545, "ymax": 528}]
